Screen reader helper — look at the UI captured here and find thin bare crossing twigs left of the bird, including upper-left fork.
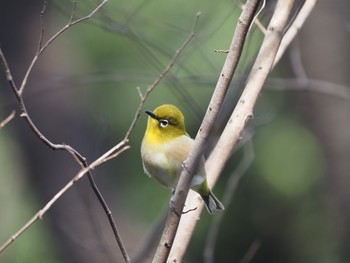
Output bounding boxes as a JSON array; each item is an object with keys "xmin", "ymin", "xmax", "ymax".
[{"xmin": 0, "ymin": 3, "xmax": 200, "ymax": 262}]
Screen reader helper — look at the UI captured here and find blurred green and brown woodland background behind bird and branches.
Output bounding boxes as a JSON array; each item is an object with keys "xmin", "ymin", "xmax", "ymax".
[{"xmin": 0, "ymin": 0, "xmax": 350, "ymax": 263}]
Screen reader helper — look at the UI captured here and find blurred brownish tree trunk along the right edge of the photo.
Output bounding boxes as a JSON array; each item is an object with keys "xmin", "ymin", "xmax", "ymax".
[{"xmin": 299, "ymin": 0, "xmax": 350, "ymax": 256}]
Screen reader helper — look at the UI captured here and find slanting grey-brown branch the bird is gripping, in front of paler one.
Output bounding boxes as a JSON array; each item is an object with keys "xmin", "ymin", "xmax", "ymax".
[{"xmin": 153, "ymin": 0, "xmax": 259, "ymax": 263}]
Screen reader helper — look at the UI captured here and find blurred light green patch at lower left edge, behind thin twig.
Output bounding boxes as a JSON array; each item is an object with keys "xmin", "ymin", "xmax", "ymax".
[{"xmin": 0, "ymin": 131, "xmax": 59, "ymax": 263}]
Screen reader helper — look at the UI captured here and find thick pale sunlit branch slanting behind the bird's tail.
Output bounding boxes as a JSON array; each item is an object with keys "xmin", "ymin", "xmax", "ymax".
[{"xmin": 169, "ymin": 0, "xmax": 294, "ymax": 262}]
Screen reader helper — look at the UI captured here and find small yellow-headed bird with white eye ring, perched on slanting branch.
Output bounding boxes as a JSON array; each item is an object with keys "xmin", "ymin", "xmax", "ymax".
[{"xmin": 141, "ymin": 104, "xmax": 224, "ymax": 214}]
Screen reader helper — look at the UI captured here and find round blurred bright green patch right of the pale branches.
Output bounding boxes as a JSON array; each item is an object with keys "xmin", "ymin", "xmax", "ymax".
[{"xmin": 256, "ymin": 120, "xmax": 324, "ymax": 196}]
